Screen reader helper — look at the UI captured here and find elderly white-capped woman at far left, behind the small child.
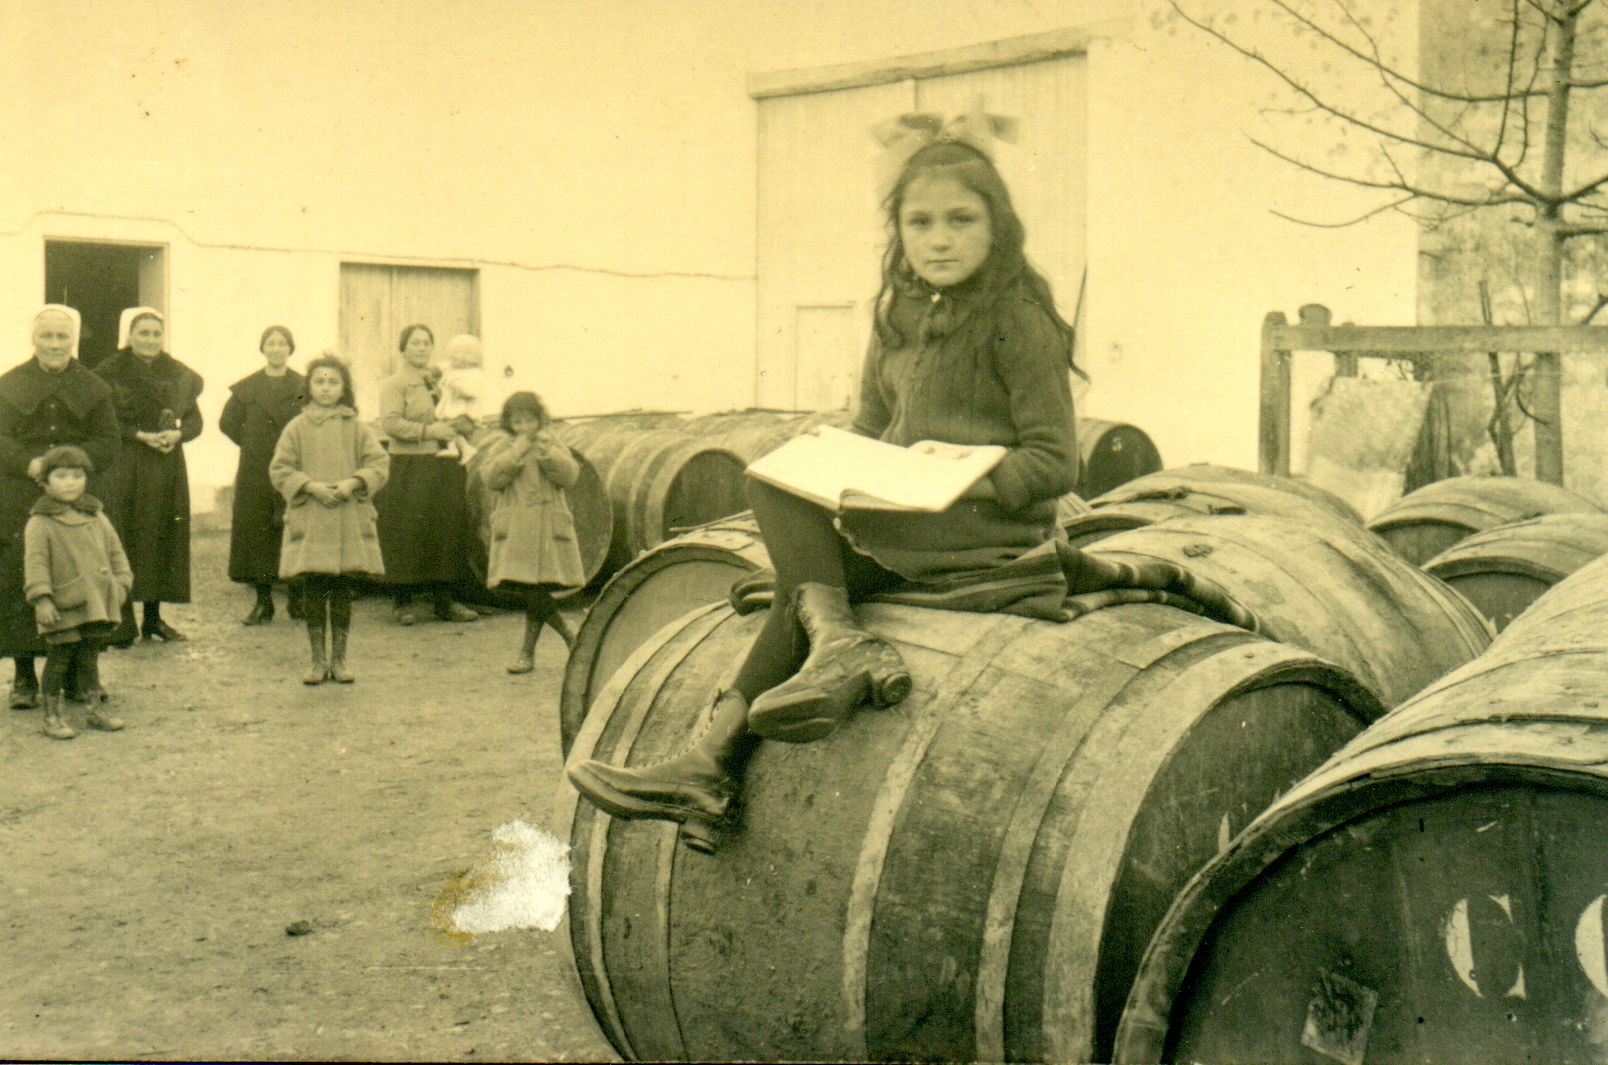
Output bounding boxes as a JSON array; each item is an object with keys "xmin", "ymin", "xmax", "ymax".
[{"xmin": 0, "ymin": 304, "xmax": 117, "ymax": 709}]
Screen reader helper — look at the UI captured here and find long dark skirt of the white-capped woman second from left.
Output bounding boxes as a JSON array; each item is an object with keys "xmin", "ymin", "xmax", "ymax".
[{"xmin": 105, "ymin": 441, "xmax": 190, "ymax": 603}]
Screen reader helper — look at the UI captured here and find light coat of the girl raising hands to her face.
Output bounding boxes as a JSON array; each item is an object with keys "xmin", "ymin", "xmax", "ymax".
[{"xmin": 481, "ymin": 430, "xmax": 587, "ymax": 589}]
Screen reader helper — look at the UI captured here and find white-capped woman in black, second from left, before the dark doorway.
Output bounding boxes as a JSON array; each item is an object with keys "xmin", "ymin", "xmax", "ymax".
[{"xmin": 95, "ymin": 307, "xmax": 201, "ymax": 647}]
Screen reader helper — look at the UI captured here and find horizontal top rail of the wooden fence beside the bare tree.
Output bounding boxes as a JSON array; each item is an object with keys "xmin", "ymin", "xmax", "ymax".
[{"xmin": 1262, "ymin": 323, "xmax": 1608, "ymax": 359}]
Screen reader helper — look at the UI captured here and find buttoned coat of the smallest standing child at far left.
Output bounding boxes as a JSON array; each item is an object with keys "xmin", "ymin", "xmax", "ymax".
[{"xmin": 23, "ymin": 495, "xmax": 133, "ymax": 635}]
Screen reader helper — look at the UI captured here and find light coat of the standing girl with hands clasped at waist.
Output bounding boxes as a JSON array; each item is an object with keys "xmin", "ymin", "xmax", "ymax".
[{"xmin": 269, "ymin": 405, "xmax": 391, "ymax": 578}]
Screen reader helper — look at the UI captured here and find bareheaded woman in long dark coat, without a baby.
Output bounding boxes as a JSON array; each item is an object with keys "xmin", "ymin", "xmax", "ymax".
[{"xmin": 217, "ymin": 325, "xmax": 306, "ymax": 624}]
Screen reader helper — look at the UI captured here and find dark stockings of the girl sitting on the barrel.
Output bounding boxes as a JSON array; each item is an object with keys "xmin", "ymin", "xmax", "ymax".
[{"xmin": 732, "ymin": 479, "xmax": 900, "ymax": 703}]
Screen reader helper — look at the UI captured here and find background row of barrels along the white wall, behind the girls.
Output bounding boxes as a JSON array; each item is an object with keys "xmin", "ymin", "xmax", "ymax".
[{"xmin": 468, "ymin": 410, "xmax": 1161, "ymax": 595}]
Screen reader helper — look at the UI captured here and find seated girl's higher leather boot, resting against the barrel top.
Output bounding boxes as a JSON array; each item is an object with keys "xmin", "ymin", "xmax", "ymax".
[{"xmin": 748, "ymin": 582, "xmax": 910, "ymax": 743}]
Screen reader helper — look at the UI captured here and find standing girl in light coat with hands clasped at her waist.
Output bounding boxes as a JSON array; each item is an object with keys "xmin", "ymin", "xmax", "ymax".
[{"xmin": 269, "ymin": 354, "xmax": 391, "ymax": 684}]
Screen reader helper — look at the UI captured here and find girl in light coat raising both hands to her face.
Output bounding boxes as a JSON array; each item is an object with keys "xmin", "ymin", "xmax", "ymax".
[{"xmin": 482, "ymin": 393, "xmax": 587, "ymax": 672}]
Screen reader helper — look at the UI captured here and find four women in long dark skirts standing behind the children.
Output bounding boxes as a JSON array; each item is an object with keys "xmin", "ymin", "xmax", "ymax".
[{"xmin": 0, "ymin": 304, "xmax": 495, "ymax": 709}]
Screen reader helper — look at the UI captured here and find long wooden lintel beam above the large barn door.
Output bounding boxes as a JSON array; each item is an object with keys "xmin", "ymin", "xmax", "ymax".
[{"xmin": 748, "ymin": 18, "xmax": 1132, "ymax": 100}]
